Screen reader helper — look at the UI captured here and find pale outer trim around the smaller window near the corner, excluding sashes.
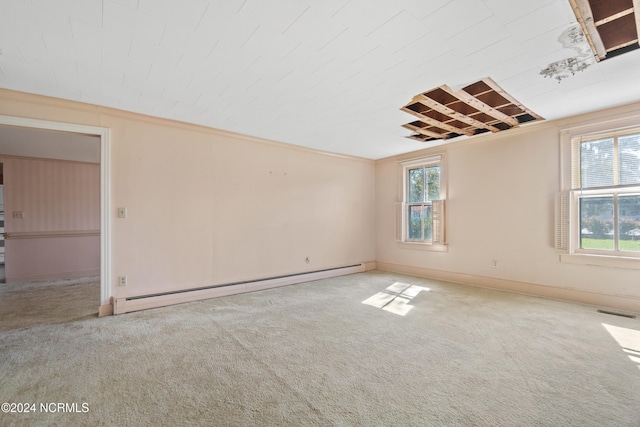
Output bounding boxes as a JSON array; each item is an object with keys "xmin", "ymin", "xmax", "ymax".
[{"xmin": 395, "ymin": 153, "xmax": 448, "ymax": 252}]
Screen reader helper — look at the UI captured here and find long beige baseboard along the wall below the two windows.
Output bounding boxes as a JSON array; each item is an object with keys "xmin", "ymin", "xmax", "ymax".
[{"xmin": 376, "ymin": 261, "xmax": 640, "ymax": 313}]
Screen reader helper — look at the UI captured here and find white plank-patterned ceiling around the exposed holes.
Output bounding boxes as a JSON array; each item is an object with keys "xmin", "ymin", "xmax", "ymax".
[{"xmin": 0, "ymin": 0, "xmax": 640, "ymax": 159}]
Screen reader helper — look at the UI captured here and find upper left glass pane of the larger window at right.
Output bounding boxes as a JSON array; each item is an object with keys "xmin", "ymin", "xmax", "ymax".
[{"xmin": 580, "ymin": 138, "xmax": 614, "ymax": 188}]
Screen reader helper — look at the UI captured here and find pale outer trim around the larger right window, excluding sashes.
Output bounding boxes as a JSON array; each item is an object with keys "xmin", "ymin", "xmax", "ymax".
[{"xmin": 555, "ymin": 112, "xmax": 640, "ymax": 269}]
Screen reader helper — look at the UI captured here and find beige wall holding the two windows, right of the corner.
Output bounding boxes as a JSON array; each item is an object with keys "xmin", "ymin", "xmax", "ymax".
[{"xmin": 376, "ymin": 105, "xmax": 640, "ymax": 312}]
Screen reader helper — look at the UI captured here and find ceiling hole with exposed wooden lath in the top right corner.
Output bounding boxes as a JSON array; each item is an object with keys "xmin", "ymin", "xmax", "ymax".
[{"xmin": 569, "ymin": 0, "xmax": 640, "ymax": 61}]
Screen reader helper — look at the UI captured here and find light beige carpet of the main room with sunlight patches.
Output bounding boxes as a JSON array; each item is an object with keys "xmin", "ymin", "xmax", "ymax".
[{"xmin": 0, "ymin": 271, "xmax": 640, "ymax": 427}]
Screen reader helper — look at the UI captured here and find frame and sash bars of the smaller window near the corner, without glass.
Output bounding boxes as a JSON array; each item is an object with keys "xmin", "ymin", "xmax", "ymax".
[{"xmin": 396, "ymin": 153, "xmax": 447, "ymax": 251}]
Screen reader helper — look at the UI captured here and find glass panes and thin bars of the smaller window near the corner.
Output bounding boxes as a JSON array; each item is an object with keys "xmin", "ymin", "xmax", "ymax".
[{"xmin": 405, "ymin": 162, "xmax": 441, "ymax": 243}]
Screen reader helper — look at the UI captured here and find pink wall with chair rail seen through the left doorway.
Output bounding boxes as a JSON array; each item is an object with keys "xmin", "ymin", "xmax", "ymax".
[{"xmin": 0, "ymin": 157, "xmax": 100, "ymax": 282}]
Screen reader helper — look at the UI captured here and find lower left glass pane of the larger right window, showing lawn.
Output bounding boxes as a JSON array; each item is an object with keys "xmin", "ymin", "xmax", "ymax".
[{"xmin": 580, "ymin": 196, "xmax": 615, "ymax": 250}]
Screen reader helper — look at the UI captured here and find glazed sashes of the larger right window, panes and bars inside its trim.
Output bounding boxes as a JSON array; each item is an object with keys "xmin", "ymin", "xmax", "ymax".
[{"xmin": 572, "ymin": 129, "xmax": 640, "ymax": 257}]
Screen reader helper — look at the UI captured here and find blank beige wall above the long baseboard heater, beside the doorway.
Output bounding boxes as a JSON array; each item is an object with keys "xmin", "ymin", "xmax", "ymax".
[{"xmin": 0, "ymin": 90, "xmax": 375, "ymax": 297}]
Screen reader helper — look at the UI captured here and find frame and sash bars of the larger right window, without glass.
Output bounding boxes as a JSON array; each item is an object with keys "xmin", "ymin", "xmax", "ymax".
[{"xmin": 556, "ymin": 113, "xmax": 640, "ymax": 269}]
